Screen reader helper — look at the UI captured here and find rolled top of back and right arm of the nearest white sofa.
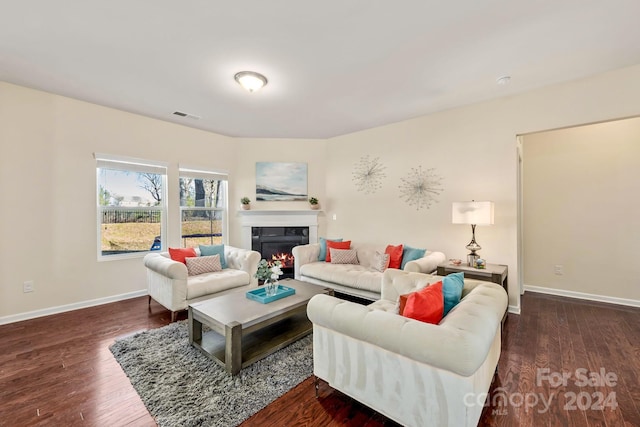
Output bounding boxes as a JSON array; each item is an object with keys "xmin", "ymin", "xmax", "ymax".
[{"xmin": 307, "ymin": 282, "xmax": 507, "ymax": 377}]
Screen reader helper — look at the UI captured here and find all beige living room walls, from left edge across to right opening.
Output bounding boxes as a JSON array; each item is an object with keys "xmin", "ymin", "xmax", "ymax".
[{"xmin": 0, "ymin": 61, "xmax": 640, "ymax": 321}]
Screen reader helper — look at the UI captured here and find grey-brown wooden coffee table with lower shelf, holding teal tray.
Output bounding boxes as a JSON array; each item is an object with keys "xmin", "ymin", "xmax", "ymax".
[{"xmin": 189, "ymin": 279, "xmax": 333, "ymax": 375}]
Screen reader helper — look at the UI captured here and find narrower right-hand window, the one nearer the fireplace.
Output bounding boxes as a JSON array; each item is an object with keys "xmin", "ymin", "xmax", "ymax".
[{"xmin": 180, "ymin": 168, "xmax": 228, "ymax": 248}]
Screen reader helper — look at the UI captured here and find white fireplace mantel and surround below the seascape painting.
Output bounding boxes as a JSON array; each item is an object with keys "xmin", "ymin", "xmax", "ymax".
[{"xmin": 238, "ymin": 210, "xmax": 321, "ymax": 249}]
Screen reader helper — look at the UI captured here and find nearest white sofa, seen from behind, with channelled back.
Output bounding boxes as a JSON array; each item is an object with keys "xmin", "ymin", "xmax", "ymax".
[{"xmin": 307, "ymin": 270, "xmax": 507, "ymax": 427}]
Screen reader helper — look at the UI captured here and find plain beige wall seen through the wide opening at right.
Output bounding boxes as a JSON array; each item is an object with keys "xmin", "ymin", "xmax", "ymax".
[{"xmin": 523, "ymin": 118, "xmax": 640, "ymax": 301}]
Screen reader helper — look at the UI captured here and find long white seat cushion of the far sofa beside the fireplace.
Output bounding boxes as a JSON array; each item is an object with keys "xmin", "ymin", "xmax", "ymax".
[{"xmin": 300, "ymin": 262, "xmax": 382, "ymax": 293}]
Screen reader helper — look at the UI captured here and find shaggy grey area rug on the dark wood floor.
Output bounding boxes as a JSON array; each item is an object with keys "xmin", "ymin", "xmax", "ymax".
[{"xmin": 110, "ymin": 321, "xmax": 313, "ymax": 427}]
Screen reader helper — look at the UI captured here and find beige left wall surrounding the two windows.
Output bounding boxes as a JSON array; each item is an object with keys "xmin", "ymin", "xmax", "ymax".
[{"xmin": 0, "ymin": 83, "xmax": 236, "ymax": 319}]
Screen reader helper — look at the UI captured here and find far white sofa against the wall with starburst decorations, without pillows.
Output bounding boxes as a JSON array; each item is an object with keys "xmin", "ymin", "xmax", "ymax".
[{"xmin": 292, "ymin": 242, "xmax": 445, "ymax": 300}]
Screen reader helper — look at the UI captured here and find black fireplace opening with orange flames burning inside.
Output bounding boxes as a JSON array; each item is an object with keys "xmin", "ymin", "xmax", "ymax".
[{"xmin": 251, "ymin": 227, "xmax": 309, "ymax": 279}]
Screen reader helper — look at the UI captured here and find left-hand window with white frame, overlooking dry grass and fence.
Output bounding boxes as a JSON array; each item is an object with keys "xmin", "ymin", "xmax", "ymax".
[{"xmin": 96, "ymin": 154, "xmax": 167, "ymax": 259}]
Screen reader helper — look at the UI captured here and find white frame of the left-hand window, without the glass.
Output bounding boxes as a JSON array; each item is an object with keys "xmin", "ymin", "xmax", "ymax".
[{"xmin": 94, "ymin": 153, "xmax": 168, "ymax": 261}]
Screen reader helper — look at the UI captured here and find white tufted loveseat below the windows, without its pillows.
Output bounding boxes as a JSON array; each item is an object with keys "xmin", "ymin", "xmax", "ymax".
[{"xmin": 144, "ymin": 245, "xmax": 261, "ymax": 322}]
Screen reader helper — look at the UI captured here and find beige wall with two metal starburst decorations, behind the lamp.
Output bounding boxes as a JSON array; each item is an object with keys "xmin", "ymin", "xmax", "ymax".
[{"xmin": 325, "ymin": 66, "xmax": 640, "ymax": 310}]
